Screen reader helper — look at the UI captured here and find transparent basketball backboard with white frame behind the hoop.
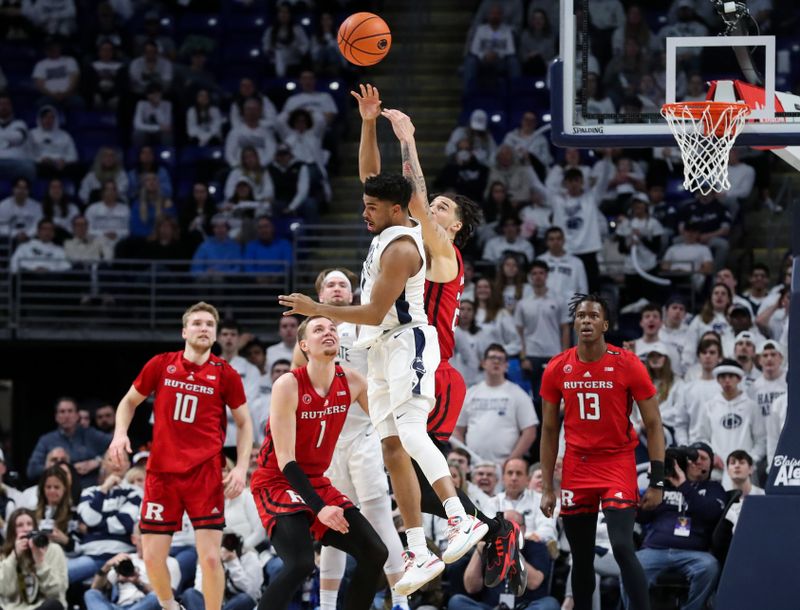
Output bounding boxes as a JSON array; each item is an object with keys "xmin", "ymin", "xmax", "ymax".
[{"xmin": 550, "ymin": 0, "xmax": 800, "ymax": 148}]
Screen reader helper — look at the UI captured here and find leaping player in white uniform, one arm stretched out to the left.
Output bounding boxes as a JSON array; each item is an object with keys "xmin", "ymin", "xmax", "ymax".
[{"xmin": 278, "ymin": 167, "xmax": 487, "ymax": 595}]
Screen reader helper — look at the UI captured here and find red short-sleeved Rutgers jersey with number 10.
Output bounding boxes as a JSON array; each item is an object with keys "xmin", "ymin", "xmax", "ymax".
[{"xmin": 133, "ymin": 351, "xmax": 247, "ymax": 472}]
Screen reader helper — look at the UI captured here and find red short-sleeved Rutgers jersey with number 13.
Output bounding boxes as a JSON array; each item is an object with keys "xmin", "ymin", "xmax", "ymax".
[{"xmin": 540, "ymin": 345, "xmax": 656, "ymax": 454}]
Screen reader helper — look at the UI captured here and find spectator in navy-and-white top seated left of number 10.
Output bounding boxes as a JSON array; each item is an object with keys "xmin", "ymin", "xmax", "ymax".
[{"xmin": 68, "ymin": 453, "xmax": 142, "ymax": 584}]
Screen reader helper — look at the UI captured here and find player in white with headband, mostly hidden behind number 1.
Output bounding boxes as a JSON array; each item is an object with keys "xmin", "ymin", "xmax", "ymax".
[{"xmin": 292, "ymin": 269, "xmax": 408, "ymax": 610}]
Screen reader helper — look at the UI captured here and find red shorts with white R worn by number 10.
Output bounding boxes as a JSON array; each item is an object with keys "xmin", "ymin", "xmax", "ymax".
[{"xmin": 140, "ymin": 456, "xmax": 225, "ymax": 534}]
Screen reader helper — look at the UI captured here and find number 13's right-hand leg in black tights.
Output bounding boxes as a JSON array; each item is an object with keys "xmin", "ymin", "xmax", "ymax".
[{"xmin": 604, "ymin": 508, "xmax": 650, "ymax": 610}]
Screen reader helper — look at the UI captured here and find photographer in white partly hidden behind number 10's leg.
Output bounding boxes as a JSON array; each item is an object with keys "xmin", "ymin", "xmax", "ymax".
[{"xmin": 180, "ymin": 533, "xmax": 264, "ymax": 610}]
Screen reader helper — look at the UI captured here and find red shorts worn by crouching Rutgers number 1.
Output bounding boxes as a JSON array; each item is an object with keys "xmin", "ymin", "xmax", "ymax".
[{"xmin": 250, "ymin": 471, "xmax": 353, "ymax": 540}]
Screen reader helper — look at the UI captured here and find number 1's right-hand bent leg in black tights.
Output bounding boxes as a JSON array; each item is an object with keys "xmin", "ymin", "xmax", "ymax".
[{"xmin": 324, "ymin": 508, "xmax": 389, "ymax": 610}]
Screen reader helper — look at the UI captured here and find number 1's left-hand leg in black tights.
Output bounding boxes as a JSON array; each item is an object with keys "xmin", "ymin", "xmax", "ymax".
[{"xmin": 258, "ymin": 513, "xmax": 315, "ymax": 610}]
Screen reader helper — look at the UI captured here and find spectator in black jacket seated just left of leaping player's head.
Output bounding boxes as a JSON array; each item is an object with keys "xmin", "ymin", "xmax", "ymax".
[{"xmin": 267, "ymin": 144, "xmax": 319, "ymax": 224}]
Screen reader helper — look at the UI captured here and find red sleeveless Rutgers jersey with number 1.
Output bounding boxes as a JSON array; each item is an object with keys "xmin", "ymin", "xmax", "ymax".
[{"xmin": 258, "ymin": 364, "xmax": 352, "ymax": 480}]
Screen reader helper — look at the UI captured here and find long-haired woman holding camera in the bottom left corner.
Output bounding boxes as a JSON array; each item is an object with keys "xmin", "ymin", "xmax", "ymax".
[{"xmin": 0, "ymin": 508, "xmax": 67, "ymax": 610}]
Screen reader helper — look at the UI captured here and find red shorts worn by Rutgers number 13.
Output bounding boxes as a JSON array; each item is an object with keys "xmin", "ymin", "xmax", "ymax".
[{"xmin": 561, "ymin": 451, "xmax": 639, "ymax": 516}]
